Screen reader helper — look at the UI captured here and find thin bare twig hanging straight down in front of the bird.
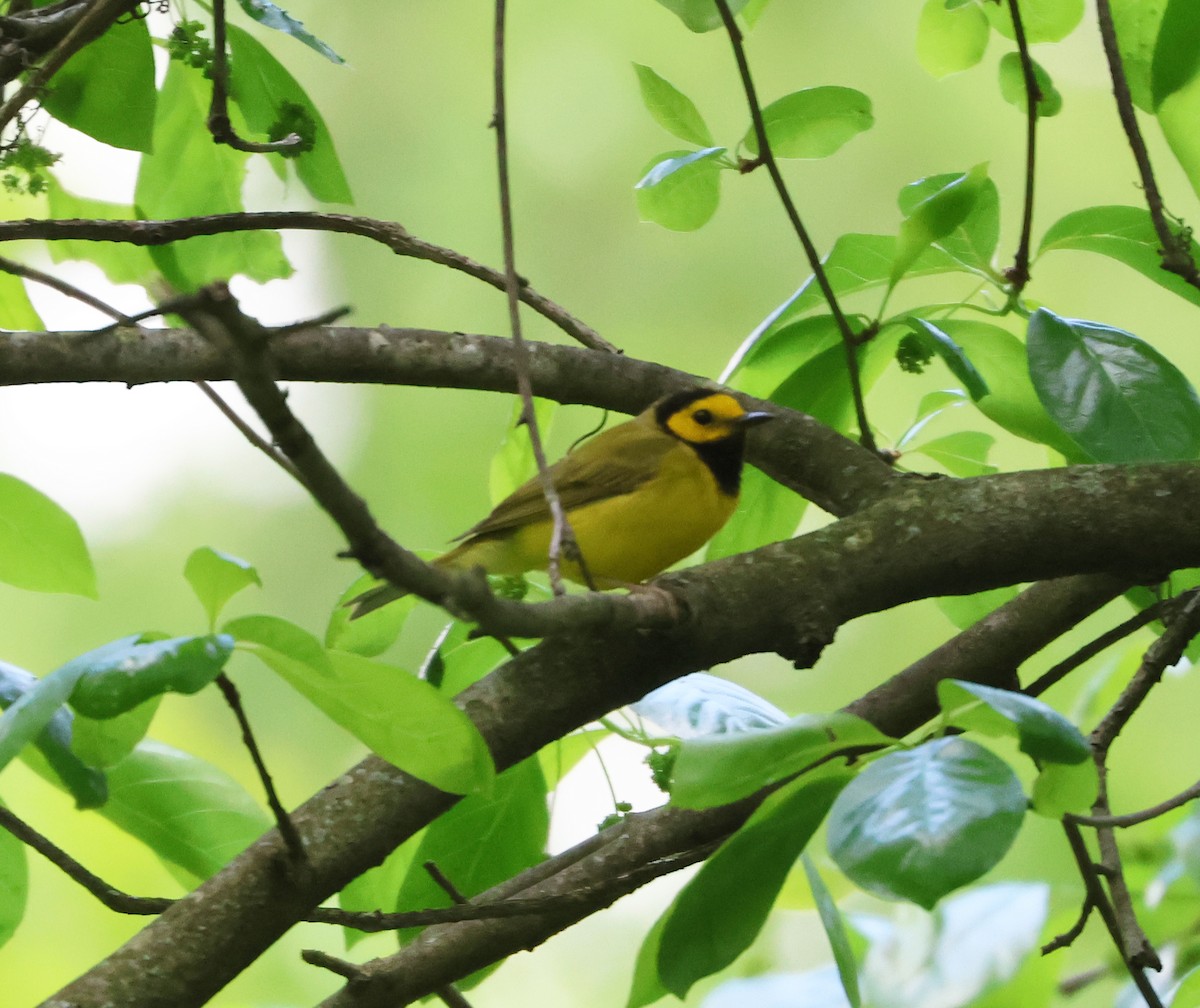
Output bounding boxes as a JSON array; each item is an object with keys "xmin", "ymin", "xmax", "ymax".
[{"xmin": 492, "ymin": 0, "xmax": 576, "ymax": 595}]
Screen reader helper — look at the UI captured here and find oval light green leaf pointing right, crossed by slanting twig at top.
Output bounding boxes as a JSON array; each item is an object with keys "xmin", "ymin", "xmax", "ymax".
[{"xmin": 742, "ymin": 86, "xmax": 875, "ymax": 158}]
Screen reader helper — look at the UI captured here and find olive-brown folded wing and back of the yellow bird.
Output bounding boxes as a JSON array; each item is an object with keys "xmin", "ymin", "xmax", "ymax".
[{"xmin": 457, "ymin": 421, "xmax": 679, "ymax": 539}]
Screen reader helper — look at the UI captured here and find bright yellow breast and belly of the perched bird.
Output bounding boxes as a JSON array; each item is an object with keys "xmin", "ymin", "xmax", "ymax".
[{"xmin": 455, "ymin": 442, "xmax": 737, "ymax": 588}]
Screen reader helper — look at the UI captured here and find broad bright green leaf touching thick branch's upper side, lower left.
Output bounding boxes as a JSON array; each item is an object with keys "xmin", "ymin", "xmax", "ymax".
[{"xmin": 101, "ymin": 742, "xmax": 271, "ymax": 878}]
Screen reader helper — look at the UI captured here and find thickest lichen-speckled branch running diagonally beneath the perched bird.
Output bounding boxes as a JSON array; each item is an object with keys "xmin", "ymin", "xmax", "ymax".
[{"xmin": 47, "ymin": 463, "xmax": 1200, "ymax": 1008}]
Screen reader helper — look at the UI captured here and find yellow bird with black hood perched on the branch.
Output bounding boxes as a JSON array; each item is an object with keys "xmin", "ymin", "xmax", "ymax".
[{"xmin": 353, "ymin": 388, "xmax": 774, "ymax": 617}]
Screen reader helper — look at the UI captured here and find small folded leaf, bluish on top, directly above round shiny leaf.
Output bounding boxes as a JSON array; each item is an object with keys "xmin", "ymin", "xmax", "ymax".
[{"xmin": 937, "ymin": 679, "xmax": 1092, "ymax": 764}]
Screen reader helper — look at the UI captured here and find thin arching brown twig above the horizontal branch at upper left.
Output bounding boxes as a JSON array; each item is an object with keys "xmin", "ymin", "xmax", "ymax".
[{"xmin": 0, "ymin": 210, "xmax": 620, "ymax": 354}]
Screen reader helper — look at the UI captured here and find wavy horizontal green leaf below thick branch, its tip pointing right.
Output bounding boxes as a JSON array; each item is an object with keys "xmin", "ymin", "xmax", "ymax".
[{"xmin": 671, "ymin": 712, "xmax": 894, "ymax": 809}]
